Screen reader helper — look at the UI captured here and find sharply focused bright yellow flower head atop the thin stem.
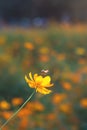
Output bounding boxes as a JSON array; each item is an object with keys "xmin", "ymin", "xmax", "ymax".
[{"xmin": 25, "ymin": 72, "xmax": 53, "ymax": 94}]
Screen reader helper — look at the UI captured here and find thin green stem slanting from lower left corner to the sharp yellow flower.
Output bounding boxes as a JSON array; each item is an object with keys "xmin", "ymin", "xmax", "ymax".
[{"xmin": 0, "ymin": 91, "xmax": 35, "ymax": 130}]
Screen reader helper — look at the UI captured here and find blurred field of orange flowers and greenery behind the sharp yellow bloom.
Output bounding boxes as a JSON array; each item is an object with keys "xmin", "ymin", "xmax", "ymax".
[{"xmin": 0, "ymin": 25, "xmax": 87, "ymax": 130}]
